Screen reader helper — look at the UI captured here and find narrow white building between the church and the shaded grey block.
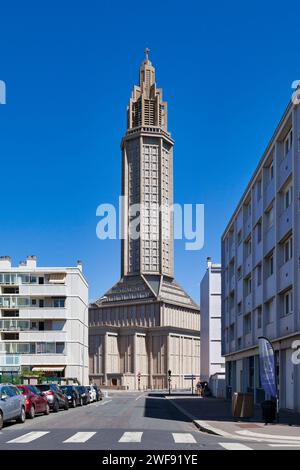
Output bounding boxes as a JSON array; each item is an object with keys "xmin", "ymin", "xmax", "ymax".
[{"xmin": 200, "ymin": 258, "xmax": 225, "ymax": 396}]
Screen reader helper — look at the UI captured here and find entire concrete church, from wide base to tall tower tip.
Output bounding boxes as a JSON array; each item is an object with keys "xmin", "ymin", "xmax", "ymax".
[{"xmin": 89, "ymin": 50, "xmax": 200, "ymax": 389}]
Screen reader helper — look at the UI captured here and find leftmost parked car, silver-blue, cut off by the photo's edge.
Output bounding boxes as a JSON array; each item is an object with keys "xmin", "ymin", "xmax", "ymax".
[{"xmin": 0, "ymin": 384, "xmax": 26, "ymax": 429}]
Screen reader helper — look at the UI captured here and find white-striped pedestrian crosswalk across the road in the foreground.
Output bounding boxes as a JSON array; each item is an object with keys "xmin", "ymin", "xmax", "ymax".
[{"xmin": 4, "ymin": 429, "xmax": 300, "ymax": 451}]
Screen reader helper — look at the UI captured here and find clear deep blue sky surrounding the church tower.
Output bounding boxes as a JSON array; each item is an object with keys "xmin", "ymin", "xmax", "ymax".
[{"xmin": 0, "ymin": 0, "xmax": 300, "ymax": 301}]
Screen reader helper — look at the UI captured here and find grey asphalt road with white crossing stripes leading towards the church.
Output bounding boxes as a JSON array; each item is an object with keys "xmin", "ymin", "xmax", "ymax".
[{"xmin": 0, "ymin": 392, "xmax": 296, "ymax": 451}]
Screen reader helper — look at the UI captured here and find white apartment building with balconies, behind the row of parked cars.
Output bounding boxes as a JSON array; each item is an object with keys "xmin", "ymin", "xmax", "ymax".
[{"xmin": 0, "ymin": 256, "xmax": 88, "ymax": 384}]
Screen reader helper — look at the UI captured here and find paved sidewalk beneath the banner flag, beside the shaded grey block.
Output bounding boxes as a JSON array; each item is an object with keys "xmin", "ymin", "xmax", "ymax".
[{"xmin": 166, "ymin": 395, "xmax": 300, "ymax": 445}]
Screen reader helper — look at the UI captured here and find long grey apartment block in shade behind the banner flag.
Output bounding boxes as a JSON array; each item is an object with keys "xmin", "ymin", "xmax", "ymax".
[{"xmin": 221, "ymin": 98, "xmax": 300, "ymax": 411}]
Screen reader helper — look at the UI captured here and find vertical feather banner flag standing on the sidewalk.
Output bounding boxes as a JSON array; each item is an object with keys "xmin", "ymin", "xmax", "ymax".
[{"xmin": 258, "ymin": 336, "xmax": 277, "ymax": 398}]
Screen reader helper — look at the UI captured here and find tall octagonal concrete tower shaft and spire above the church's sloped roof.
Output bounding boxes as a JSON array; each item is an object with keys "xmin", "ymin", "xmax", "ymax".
[{"xmin": 121, "ymin": 49, "xmax": 174, "ymax": 277}]
